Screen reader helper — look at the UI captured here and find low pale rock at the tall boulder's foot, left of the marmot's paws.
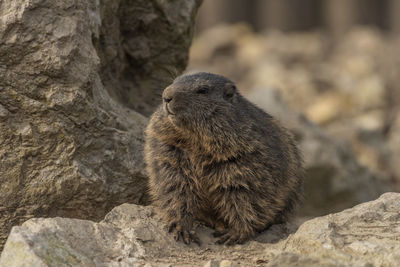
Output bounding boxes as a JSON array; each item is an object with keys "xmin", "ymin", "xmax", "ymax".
[{"xmin": 0, "ymin": 204, "xmax": 256, "ymax": 267}]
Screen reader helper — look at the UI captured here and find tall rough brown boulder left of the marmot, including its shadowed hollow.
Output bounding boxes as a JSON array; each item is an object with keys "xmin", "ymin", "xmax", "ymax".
[{"xmin": 0, "ymin": 0, "xmax": 200, "ymax": 249}]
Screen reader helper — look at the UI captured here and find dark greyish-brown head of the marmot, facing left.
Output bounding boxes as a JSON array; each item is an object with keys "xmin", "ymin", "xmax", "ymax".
[{"xmin": 162, "ymin": 72, "xmax": 238, "ymax": 128}]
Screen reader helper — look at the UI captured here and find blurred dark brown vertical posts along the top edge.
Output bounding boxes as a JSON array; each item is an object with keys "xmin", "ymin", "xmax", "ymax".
[{"xmin": 197, "ymin": 0, "xmax": 400, "ymax": 34}]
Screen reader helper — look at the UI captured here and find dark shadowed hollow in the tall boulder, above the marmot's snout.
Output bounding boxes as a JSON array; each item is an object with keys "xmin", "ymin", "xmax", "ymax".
[{"xmin": 94, "ymin": 0, "xmax": 202, "ymax": 115}]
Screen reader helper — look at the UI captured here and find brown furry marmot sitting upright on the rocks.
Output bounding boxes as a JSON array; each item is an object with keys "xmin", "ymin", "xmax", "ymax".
[{"xmin": 145, "ymin": 72, "xmax": 303, "ymax": 245}]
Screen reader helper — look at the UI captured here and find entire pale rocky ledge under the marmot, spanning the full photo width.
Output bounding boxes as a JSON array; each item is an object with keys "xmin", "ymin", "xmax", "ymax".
[{"xmin": 0, "ymin": 193, "xmax": 400, "ymax": 267}]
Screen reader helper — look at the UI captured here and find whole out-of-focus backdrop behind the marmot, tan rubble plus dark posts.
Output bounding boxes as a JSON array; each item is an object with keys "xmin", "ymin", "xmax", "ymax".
[{"xmin": 188, "ymin": 0, "xmax": 400, "ymax": 215}]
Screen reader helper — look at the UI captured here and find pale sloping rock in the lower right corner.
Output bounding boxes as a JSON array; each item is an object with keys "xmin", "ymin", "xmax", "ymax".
[{"xmin": 276, "ymin": 193, "xmax": 400, "ymax": 266}]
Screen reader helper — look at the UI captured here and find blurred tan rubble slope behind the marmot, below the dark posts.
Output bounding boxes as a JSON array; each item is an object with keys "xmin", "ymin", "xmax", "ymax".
[{"xmin": 189, "ymin": 24, "xmax": 400, "ymax": 215}]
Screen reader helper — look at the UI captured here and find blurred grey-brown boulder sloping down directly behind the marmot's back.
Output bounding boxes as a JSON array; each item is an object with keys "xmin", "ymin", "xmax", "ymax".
[{"xmin": 247, "ymin": 89, "xmax": 389, "ymax": 216}]
